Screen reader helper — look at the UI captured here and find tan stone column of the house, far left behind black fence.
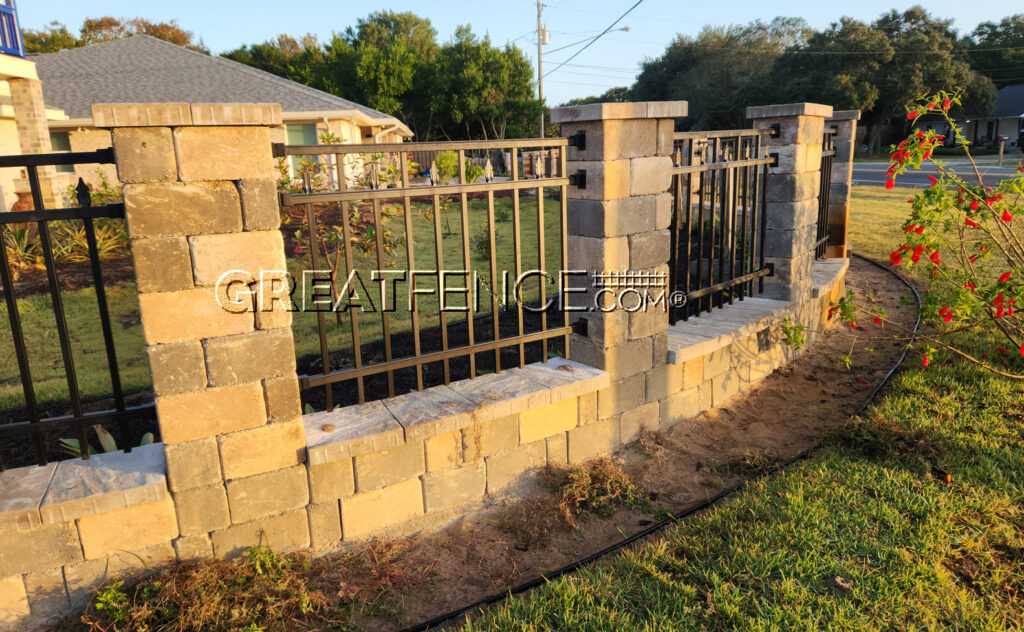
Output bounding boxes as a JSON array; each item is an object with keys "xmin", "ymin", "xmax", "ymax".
[{"xmin": 7, "ymin": 77, "xmax": 63, "ymax": 208}]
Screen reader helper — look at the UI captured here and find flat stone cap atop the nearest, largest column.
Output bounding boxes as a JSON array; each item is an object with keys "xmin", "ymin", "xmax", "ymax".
[{"xmin": 92, "ymin": 103, "xmax": 281, "ymax": 128}]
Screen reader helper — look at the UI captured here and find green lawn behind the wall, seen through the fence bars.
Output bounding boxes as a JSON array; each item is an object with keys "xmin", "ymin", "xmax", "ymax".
[{"xmin": 0, "ymin": 196, "xmax": 561, "ymax": 409}]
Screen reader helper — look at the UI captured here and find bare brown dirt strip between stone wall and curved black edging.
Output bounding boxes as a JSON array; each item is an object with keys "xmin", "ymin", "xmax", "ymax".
[{"xmin": 59, "ymin": 260, "xmax": 916, "ymax": 630}]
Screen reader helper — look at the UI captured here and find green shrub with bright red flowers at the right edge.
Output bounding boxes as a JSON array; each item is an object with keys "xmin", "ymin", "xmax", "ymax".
[{"xmin": 834, "ymin": 91, "xmax": 1024, "ymax": 379}]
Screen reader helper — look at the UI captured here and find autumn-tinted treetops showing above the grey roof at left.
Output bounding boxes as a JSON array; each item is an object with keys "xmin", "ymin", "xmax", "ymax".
[{"xmin": 23, "ymin": 15, "xmax": 210, "ymax": 54}]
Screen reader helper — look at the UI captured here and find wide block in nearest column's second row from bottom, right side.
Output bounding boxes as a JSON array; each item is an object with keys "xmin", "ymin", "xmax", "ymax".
[{"xmin": 223, "ymin": 465, "xmax": 309, "ymax": 522}]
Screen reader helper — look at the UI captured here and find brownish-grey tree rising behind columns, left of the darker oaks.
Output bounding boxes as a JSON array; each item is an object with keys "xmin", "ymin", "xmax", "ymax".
[{"xmin": 631, "ymin": 17, "xmax": 810, "ymax": 129}]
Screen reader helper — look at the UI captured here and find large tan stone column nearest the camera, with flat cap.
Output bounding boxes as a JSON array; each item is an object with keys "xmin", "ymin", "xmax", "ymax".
[{"xmin": 92, "ymin": 103, "xmax": 309, "ymax": 558}]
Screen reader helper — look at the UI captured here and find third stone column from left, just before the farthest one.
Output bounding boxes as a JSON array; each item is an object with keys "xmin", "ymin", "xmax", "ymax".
[{"xmin": 746, "ymin": 103, "xmax": 833, "ymax": 304}]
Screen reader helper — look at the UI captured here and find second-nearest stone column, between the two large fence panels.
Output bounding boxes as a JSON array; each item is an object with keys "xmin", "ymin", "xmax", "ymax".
[{"xmin": 551, "ymin": 101, "xmax": 687, "ymax": 452}]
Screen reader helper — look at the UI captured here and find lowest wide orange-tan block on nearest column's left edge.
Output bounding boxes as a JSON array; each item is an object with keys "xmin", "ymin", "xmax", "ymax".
[{"xmin": 157, "ymin": 382, "xmax": 266, "ymax": 445}]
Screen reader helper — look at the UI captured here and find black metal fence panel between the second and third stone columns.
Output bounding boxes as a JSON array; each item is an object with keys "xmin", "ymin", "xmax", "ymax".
[{"xmin": 669, "ymin": 129, "xmax": 776, "ymax": 324}]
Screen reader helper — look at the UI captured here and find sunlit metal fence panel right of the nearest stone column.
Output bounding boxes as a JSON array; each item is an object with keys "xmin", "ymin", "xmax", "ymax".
[{"xmin": 274, "ymin": 138, "xmax": 571, "ymax": 411}]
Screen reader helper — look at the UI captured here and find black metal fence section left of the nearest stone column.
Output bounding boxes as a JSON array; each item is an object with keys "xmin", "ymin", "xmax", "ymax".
[{"xmin": 0, "ymin": 149, "xmax": 156, "ymax": 470}]
